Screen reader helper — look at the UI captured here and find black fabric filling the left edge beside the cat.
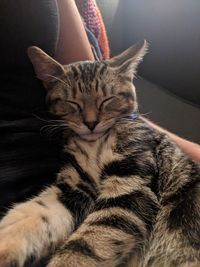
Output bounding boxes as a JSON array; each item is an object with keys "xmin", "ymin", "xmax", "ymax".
[{"xmin": 0, "ymin": 0, "xmax": 60, "ymax": 217}]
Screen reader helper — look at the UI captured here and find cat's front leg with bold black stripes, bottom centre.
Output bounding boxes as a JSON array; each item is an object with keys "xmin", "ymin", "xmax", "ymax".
[{"xmin": 48, "ymin": 177, "xmax": 159, "ymax": 267}]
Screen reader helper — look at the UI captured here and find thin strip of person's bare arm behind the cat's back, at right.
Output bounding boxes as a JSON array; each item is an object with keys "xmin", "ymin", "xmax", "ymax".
[{"xmin": 142, "ymin": 117, "xmax": 200, "ymax": 162}]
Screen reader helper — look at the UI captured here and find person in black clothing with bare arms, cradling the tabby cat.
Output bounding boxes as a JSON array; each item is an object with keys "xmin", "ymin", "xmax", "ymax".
[{"xmin": 0, "ymin": 0, "xmax": 200, "ymax": 220}]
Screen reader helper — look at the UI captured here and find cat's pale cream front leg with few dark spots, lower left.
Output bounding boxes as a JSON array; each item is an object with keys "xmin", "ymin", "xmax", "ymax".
[{"xmin": 0, "ymin": 186, "xmax": 73, "ymax": 267}]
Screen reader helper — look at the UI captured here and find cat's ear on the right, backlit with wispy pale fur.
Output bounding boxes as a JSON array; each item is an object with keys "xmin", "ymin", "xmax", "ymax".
[{"xmin": 107, "ymin": 40, "xmax": 148, "ymax": 80}]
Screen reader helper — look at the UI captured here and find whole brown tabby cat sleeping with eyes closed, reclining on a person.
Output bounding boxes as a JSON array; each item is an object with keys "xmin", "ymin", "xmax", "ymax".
[{"xmin": 0, "ymin": 42, "xmax": 200, "ymax": 267}]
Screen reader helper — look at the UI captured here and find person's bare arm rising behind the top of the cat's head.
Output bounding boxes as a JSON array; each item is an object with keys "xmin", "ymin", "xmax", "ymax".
[{"xmin": 55, "ymin": 0, "xmax": 94, "ymax": 64}]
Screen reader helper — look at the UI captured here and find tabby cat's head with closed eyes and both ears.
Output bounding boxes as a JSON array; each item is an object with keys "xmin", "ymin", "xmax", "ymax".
[{"xmin": 28, "ymin": 41, "xmax": 147, "ymax": 141}]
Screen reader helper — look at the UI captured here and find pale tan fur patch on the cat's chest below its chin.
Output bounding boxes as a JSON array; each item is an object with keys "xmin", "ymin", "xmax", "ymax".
[{"xmin": 67, "ymin": 136, "xmax": 120, "ymax": 183}]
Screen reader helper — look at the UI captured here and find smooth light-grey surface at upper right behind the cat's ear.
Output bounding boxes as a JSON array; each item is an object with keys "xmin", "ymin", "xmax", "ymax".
[{"xmin": 123, "ymin": 0, "xmax": 200, "ymax": 107}]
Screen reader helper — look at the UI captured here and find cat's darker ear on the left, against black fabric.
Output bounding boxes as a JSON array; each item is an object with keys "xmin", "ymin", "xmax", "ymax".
[{"xmin": 27, "ymin": 46, "xmax": 64, "ymax": 87}]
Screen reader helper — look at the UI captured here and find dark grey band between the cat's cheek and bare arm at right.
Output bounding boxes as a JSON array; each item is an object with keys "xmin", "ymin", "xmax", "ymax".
[{"xmin": 134, "ymin": 78, "xmax": 200, "ymax": 144}]
